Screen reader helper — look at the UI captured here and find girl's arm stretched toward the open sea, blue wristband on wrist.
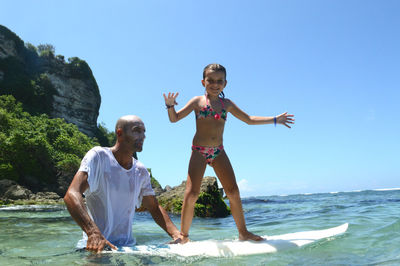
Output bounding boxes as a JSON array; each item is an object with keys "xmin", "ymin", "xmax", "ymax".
[{"xmin": 228, "ymin": 101, "xmax": 294, "ymax": 128}]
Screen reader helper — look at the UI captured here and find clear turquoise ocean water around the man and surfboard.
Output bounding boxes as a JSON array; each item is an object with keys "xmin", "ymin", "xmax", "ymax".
[{"xmin": 0, "ymin": 189, "xmax": 400, "ymax": 266}]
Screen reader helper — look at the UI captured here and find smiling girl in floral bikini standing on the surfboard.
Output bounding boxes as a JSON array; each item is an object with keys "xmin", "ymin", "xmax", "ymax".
[{"xmin": 163, "ymin": 64, "xmax": 294, "ymax": 243}]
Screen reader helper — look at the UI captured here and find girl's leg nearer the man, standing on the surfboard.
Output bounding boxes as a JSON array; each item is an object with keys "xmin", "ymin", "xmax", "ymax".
[{"xmin": 181, "ymin": 151, "xmax": 207, "ymax": 243}]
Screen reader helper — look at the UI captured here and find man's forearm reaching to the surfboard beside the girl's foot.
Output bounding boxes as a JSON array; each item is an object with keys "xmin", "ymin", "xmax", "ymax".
[{"xmin": 142, "ymin": 196, "xmax": 180, "ymax": 240}]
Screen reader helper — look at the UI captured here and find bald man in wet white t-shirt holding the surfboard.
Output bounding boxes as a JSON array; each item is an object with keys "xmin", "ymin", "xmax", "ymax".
[{"xmin": 64, "ymin": 115, "xmax": 180, "ymax": 253}]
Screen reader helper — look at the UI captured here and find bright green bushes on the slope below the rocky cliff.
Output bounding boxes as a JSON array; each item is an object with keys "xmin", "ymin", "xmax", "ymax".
[{"xmin": 0, "ymin": 96, "xmax": 98, "ymax": 191}]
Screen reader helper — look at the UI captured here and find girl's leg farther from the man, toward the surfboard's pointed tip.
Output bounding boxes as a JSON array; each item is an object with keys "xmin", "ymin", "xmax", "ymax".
[{"xmin": 212, "ymin": 150, "xmax": 263, "ymax": 241}]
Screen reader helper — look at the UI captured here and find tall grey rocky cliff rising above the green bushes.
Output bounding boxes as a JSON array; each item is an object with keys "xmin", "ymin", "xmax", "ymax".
[{"xmin": 0, "ymin": 25, "xmax": 101, "ymax": 137}]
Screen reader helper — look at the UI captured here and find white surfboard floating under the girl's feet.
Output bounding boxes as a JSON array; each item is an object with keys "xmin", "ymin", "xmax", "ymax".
[{"xmin": 104, "ymin": 223, "xmax": 349, "ymax": 257}]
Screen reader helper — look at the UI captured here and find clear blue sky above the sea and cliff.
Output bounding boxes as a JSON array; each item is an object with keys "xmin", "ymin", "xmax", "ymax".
[{"xmin": 0, "ymin": 0, "xmax": 400, "ymax": 197}]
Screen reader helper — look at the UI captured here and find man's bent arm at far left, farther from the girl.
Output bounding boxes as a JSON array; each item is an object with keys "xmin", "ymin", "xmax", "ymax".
[{"xmin": 64, "ymin": 171, "xmax": 116, "ymax": 253}]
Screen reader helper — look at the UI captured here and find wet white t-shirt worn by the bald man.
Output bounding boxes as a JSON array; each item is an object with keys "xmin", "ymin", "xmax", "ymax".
[{"xmin": 77, "ymin": 147, "xmax": 155, "ymax": 248}]
